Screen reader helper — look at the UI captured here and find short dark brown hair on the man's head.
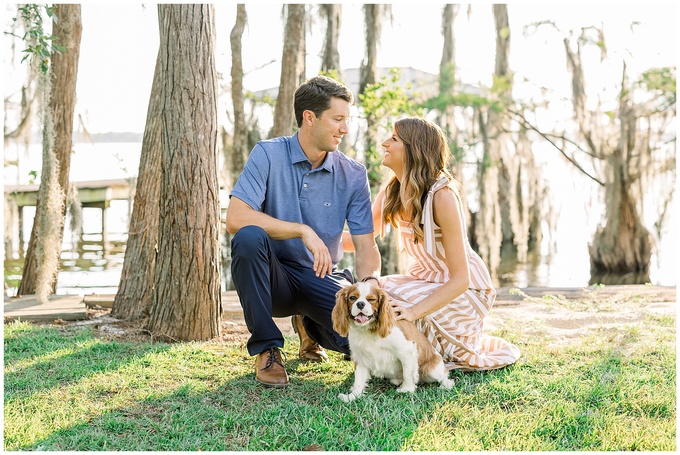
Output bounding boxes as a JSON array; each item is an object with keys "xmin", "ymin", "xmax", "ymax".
[{"xmin": 293, "ymin": 76, "xmax": 354, "ymax": 128}]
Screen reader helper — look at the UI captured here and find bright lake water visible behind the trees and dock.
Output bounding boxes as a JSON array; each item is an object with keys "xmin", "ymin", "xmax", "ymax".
[{"xmin": 4, "ymin": 143, "xmax": 677, "ymax": 295}]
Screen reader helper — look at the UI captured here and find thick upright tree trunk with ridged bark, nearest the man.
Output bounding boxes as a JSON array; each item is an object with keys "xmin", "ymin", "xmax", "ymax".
[{"xmin": 149, "ymin": 4, "xmax": 222, "ymax": 340}]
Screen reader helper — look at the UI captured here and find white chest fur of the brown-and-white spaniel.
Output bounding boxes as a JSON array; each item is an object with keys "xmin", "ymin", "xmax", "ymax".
[{"xmin": 348, "ymin": 327, "xmax": 417, "ymax": 379}]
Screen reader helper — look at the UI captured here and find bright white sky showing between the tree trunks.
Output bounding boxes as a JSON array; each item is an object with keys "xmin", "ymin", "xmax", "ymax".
[{"xmin": 3, "ymin": 1, "xmax": 678, "ymax": 133}]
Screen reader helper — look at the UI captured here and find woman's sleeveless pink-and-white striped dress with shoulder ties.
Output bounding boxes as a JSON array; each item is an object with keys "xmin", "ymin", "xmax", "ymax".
[{"xmin": 381, "ymin": 177, "xmax": 520, "ymax": 371}]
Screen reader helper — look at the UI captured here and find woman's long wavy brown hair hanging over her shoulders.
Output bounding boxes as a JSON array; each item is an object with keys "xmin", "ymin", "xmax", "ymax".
[{"xmin": 383, "ymin": 117, "xmax": 459, "ymax": 243}]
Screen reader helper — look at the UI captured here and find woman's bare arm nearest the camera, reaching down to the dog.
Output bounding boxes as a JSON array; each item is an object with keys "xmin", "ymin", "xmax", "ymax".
[{"xmin": 394, "ymin": 188, "xmax": 470, "ymax": 321}]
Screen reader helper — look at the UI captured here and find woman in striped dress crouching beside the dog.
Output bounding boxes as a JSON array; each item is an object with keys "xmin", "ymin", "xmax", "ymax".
[{"xmin": 373, "ymin": 118, "xmax": 520, "ymax": 371}]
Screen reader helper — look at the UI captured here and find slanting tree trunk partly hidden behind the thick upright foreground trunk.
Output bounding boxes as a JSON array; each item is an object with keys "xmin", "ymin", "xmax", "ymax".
[{"xmin": 111, "ymin": 49, "xmax": 164, "ymax": 319}]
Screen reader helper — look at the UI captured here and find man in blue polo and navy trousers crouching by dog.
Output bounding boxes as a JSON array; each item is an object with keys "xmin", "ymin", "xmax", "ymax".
[{"xmin": 227, "ymin": 77, "xmax": 380, "ymax": 387}]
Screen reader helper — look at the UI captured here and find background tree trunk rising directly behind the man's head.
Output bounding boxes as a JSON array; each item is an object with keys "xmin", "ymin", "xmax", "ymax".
[{"xmin": 271, "ymin": 4, "xmax": 305, "ymax": 137}]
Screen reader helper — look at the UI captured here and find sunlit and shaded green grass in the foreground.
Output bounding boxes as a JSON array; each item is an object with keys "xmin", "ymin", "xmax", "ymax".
[{"xmin": 4, "ymin": 312, "xmax": 676, "ymax": 451}]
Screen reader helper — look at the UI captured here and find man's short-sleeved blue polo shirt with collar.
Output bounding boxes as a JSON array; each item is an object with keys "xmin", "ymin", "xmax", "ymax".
[{"xmin": 230, "ymin": 133, "xmax": 373, "ymax": 268}]
